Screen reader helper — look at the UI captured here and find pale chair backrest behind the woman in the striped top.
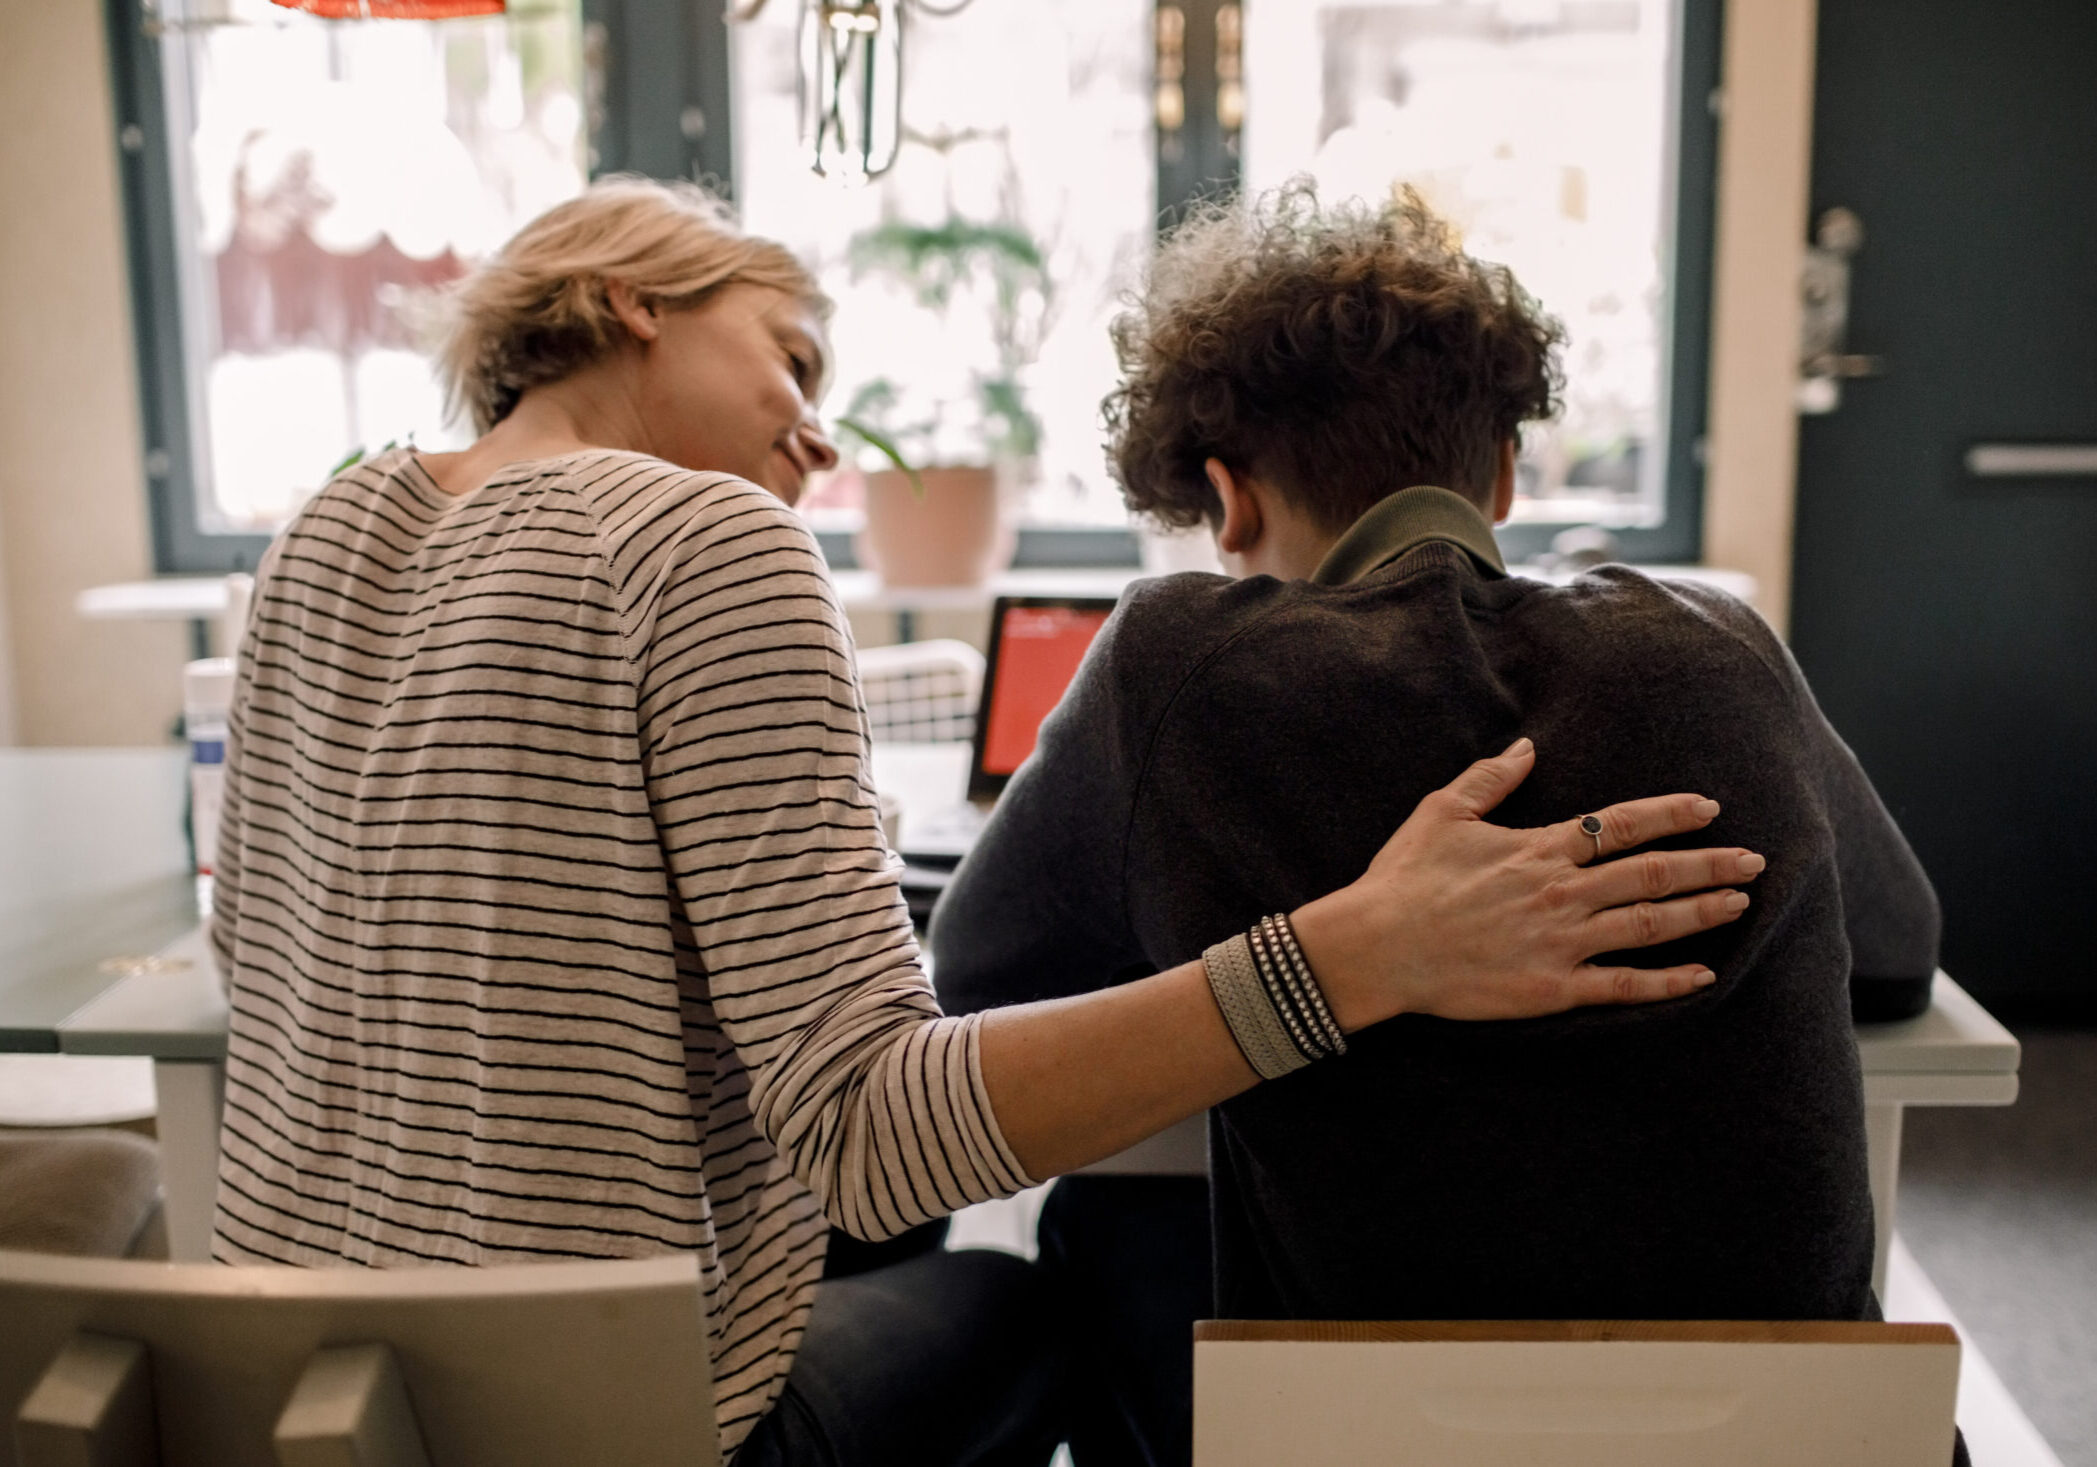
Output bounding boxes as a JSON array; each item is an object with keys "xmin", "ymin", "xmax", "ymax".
[{"xmin": 0, "ymin": 1253, "xmax": 719, "ymax": 1467}]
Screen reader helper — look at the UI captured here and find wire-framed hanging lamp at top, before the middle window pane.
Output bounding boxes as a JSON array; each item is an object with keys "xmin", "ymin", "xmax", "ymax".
[{"xmin": 725, "ymin": 0, "xmax": 973, "ymax": 184}]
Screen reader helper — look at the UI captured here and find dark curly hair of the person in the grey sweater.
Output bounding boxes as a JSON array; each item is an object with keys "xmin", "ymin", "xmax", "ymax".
[{"xmin": 1103, "ymin": 180, "xmax": 1564, "ymax": 530}]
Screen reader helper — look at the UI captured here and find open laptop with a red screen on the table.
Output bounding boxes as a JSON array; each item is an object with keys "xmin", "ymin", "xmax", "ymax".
[{"xmin": 902, "ymin": 595, "xmax": 1116, "ymax": 912}]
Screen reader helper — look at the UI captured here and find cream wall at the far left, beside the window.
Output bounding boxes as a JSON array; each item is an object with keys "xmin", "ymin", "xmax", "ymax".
[{"xmin": 0, "ymin": 0, "xmax": 187, "ymax": 744}]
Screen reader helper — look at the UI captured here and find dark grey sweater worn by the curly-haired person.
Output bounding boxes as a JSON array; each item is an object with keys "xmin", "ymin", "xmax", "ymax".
[{"xmin": 931, "ymin": 488, "xmax": 1938, "ymax": 1318}]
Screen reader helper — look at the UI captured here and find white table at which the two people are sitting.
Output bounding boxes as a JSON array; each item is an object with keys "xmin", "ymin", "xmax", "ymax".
[{"xmin": 57, "ymin": 744, "xmax": 2019, "ymax": 1293}]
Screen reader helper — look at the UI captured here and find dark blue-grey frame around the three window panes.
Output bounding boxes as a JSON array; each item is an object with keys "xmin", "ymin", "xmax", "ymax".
[{"xmin": 105, "ymin": 0, "xmax": 1724, "ymax": 574}]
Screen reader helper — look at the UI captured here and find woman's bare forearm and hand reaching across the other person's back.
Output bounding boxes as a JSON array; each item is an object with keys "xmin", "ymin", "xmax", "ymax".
[{"xmin": 981, "ymin": 740, "xmax": 1761, "ymax": 1178}]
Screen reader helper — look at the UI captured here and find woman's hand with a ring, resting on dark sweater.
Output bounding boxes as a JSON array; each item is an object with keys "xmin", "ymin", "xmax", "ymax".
[{"xmin": 1290, "ymin": 738, "xmax": 1764, "ymax": 1031}]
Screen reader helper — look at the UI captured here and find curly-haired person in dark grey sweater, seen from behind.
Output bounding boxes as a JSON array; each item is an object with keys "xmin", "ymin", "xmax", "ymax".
[{"xmin": 931, "ymin": 187, "xmax": 1938, "ymax": 1467}]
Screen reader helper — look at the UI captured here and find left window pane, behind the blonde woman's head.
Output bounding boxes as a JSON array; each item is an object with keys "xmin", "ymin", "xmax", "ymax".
[{"xmin": 159, "ymin": 0, "xmax": 585, "ymax": 532}]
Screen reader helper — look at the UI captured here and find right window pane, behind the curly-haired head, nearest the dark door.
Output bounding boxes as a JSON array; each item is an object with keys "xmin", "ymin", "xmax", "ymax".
[{"xmin": 1244, "ymin": 0, "xmax": 1676, "ymax": 526}]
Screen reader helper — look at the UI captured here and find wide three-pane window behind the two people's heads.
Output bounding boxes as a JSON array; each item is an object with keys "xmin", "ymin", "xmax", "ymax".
[{"xmin": 105, "ymin": 0, "xmax": 1717, "ymax": 572}]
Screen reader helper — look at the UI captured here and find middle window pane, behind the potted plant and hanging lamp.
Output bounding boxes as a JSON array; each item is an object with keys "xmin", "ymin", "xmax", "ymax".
[{"xmin": 730, "ymin": 0, "xmax": 1155, "ymax": 528}]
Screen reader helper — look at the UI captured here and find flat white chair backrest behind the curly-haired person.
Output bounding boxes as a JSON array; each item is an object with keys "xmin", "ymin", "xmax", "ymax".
[{"xmin": 1193, "ymin": 1320, "xmax": 1959, "ymax": 1467}]
